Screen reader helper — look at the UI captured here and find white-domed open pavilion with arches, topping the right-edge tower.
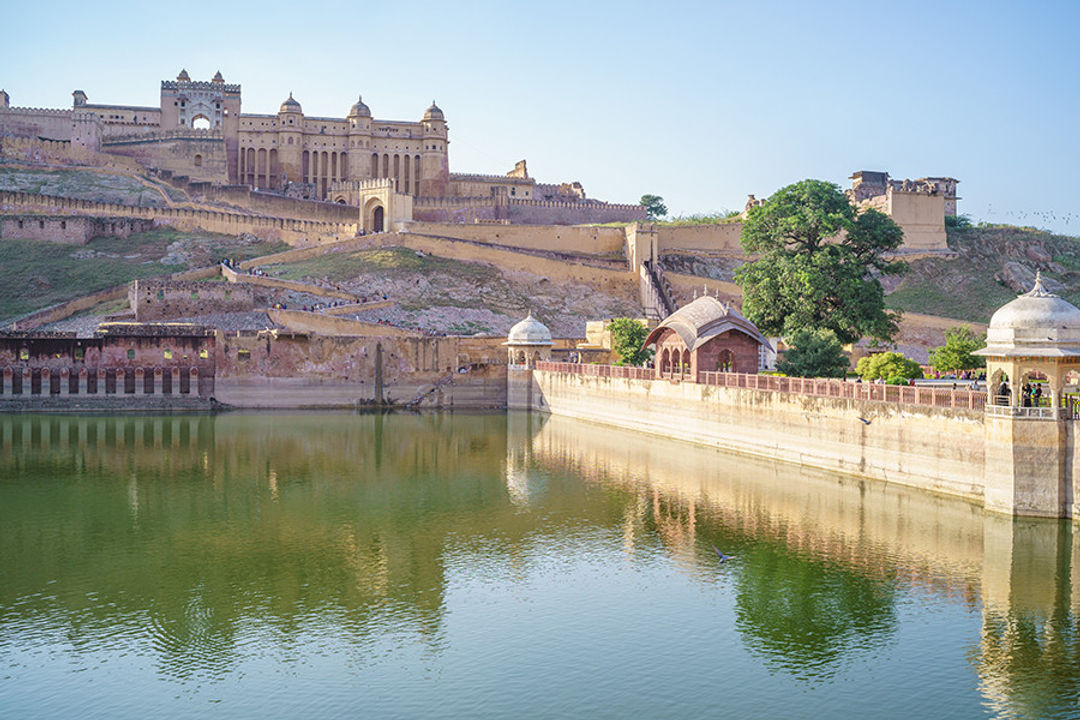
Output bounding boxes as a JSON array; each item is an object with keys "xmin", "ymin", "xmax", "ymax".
[{"xmin": 974, "ymin": 273, "xmax": 1080, "ymax": 419}]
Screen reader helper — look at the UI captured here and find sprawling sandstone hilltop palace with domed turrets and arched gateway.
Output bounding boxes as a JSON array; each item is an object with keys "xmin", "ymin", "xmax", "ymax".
[{"xmin": 0, "ymin": 70, "xmax": 645, "ymax": 230}]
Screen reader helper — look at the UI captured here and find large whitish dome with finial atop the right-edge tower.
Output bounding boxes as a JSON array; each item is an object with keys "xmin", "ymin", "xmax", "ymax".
[{"xmin": 975, "ymin": 273, "xmax": 1080, "ymax": 357}]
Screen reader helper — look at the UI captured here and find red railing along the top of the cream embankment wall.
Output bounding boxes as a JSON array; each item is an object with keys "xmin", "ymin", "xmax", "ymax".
[{"xmin": 537, "ymin": 363, "xmax": 986, "ymax": 410}]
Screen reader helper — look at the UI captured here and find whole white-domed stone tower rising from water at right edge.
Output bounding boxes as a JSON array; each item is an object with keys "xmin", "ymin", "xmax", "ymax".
[{"xmin": 975, "ymin": 276, "xmax": 1080, "ymax": 517}]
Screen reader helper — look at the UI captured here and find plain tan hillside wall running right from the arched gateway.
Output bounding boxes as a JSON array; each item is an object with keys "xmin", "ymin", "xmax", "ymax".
[{"xmin": 402, "ymin": 221, "xmax": 626, "ymax": 255}]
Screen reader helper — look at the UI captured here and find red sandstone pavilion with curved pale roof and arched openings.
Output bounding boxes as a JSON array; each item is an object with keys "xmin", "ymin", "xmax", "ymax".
[{"xmin": 645, "ymin": 296, "xmax": 772, "ymax": 382}]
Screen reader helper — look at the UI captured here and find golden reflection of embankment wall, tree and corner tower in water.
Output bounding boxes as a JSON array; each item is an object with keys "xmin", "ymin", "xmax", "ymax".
[{"xmin": 529, "ymin": 416, "xmax": 1080, "ymax": 717}]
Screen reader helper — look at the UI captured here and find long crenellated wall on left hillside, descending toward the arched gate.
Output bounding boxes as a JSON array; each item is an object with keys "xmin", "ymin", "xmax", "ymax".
[{"xmin": 0, "ymin": 191, "xmax": 356, "ymax": 244}]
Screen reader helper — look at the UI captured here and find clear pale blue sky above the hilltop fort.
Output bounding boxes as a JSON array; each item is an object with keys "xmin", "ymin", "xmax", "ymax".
[{"xmin": 0, "ymin": 0, "xmax": 1080, "ymax": 235}]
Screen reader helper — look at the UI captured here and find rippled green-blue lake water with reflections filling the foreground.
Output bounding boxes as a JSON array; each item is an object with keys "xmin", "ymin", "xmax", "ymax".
[{"xmin": 0, "ymin": 413, "xmax": 1080, "ymax": 718}]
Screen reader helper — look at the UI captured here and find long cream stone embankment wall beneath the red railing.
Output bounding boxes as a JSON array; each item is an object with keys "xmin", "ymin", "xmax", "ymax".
[{"xmin": 518, "ymin": 369, "xmax": 985, "ymax": 503}]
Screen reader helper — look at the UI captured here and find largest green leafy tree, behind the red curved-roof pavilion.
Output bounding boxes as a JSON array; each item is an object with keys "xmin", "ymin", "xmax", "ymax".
[{"xmin": 735, "ymin": 180, "xmax": 907, "ymax": 343}]
